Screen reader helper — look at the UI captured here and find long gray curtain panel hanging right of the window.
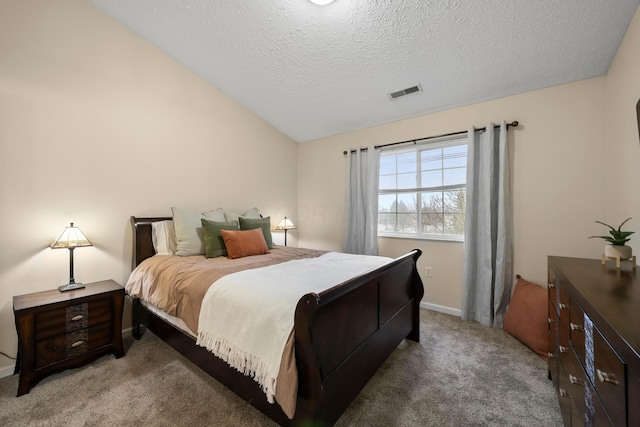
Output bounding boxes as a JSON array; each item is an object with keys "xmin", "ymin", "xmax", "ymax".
[{"xmin": 462, "ymin": 123, "xmax": 513, "ymax": 328}]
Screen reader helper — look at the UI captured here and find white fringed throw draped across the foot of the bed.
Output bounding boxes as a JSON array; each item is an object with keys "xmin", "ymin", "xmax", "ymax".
[{"xmin": 197, "ymin": 252, "xmax": 392, "ymax": 403}]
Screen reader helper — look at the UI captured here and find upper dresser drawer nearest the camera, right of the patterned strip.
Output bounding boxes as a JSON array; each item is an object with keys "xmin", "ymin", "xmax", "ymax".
[{"xmin": 593, "ymin": 326, "xmax": 627, "ymax": 426}]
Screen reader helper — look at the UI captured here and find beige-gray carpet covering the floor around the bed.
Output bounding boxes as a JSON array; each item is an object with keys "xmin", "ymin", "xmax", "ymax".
[{"xmin": 0, "ymin": 310, "xmax": 562, "ymax": 427}]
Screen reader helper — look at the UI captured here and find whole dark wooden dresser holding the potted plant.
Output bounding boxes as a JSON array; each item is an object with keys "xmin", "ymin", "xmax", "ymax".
[{"xmin": 548, "ymin": 256, "xmax": 640, "ymax": 426}]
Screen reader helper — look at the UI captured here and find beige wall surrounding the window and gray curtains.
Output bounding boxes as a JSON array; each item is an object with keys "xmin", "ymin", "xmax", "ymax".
[{"xmin": 298, "ymin": 77, "xmax": 605, "ymax": 313}]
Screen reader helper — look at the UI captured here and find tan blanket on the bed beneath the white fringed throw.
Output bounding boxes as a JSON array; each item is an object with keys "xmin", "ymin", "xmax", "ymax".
[{"xmin": 125, "ymin": 246, "xmax": 326, "ymax": 418}]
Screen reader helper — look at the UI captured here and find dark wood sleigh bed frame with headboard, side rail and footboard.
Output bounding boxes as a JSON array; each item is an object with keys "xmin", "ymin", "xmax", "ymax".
[{"xmin": 131, "ymin": 217, "xmax": 424, "ymax": 426}]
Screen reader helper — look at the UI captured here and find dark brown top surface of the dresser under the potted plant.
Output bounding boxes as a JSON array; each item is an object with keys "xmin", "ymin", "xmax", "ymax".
[{"xmin": 549, "ymin": 256, "xmax": 640, "ymax": 373}]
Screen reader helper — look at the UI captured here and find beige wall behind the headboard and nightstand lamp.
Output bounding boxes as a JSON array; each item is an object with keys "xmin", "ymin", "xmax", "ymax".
[{"xmin": 0, "ymin": 0, "xmax": 297, "ymax": 370}]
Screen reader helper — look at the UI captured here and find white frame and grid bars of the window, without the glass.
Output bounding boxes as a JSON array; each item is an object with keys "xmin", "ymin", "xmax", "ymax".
[{"xmin": 377, "ymin": 135, "xmax": 468, "ymax": 242}]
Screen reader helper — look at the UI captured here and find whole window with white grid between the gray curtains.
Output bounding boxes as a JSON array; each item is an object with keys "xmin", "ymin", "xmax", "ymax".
[{"xmin": 378, "ymin": 137, "xmax": 467, "ymax": 240}]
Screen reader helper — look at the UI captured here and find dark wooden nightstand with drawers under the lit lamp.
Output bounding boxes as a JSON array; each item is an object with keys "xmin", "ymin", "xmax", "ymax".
[{"xmin": 13, "ymin": 280, "xmax": 124, "ymax": 396}]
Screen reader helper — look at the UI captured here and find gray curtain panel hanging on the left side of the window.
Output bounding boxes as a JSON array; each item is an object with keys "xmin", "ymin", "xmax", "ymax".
[{"xmin": 344, "ymin": 147, "xmax": 380, "ymax": 255}]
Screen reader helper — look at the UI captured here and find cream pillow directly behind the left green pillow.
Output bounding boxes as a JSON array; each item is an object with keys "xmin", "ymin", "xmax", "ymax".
[{"xmin": 171, "ymin": 208, "xmax": 225, "ymax": 256}]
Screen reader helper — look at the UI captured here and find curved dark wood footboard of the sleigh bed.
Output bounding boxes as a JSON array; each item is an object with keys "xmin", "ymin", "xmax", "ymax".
[{"xmin": 294, "ymin": 249, "xmax": 424, "ymax": 426}]
